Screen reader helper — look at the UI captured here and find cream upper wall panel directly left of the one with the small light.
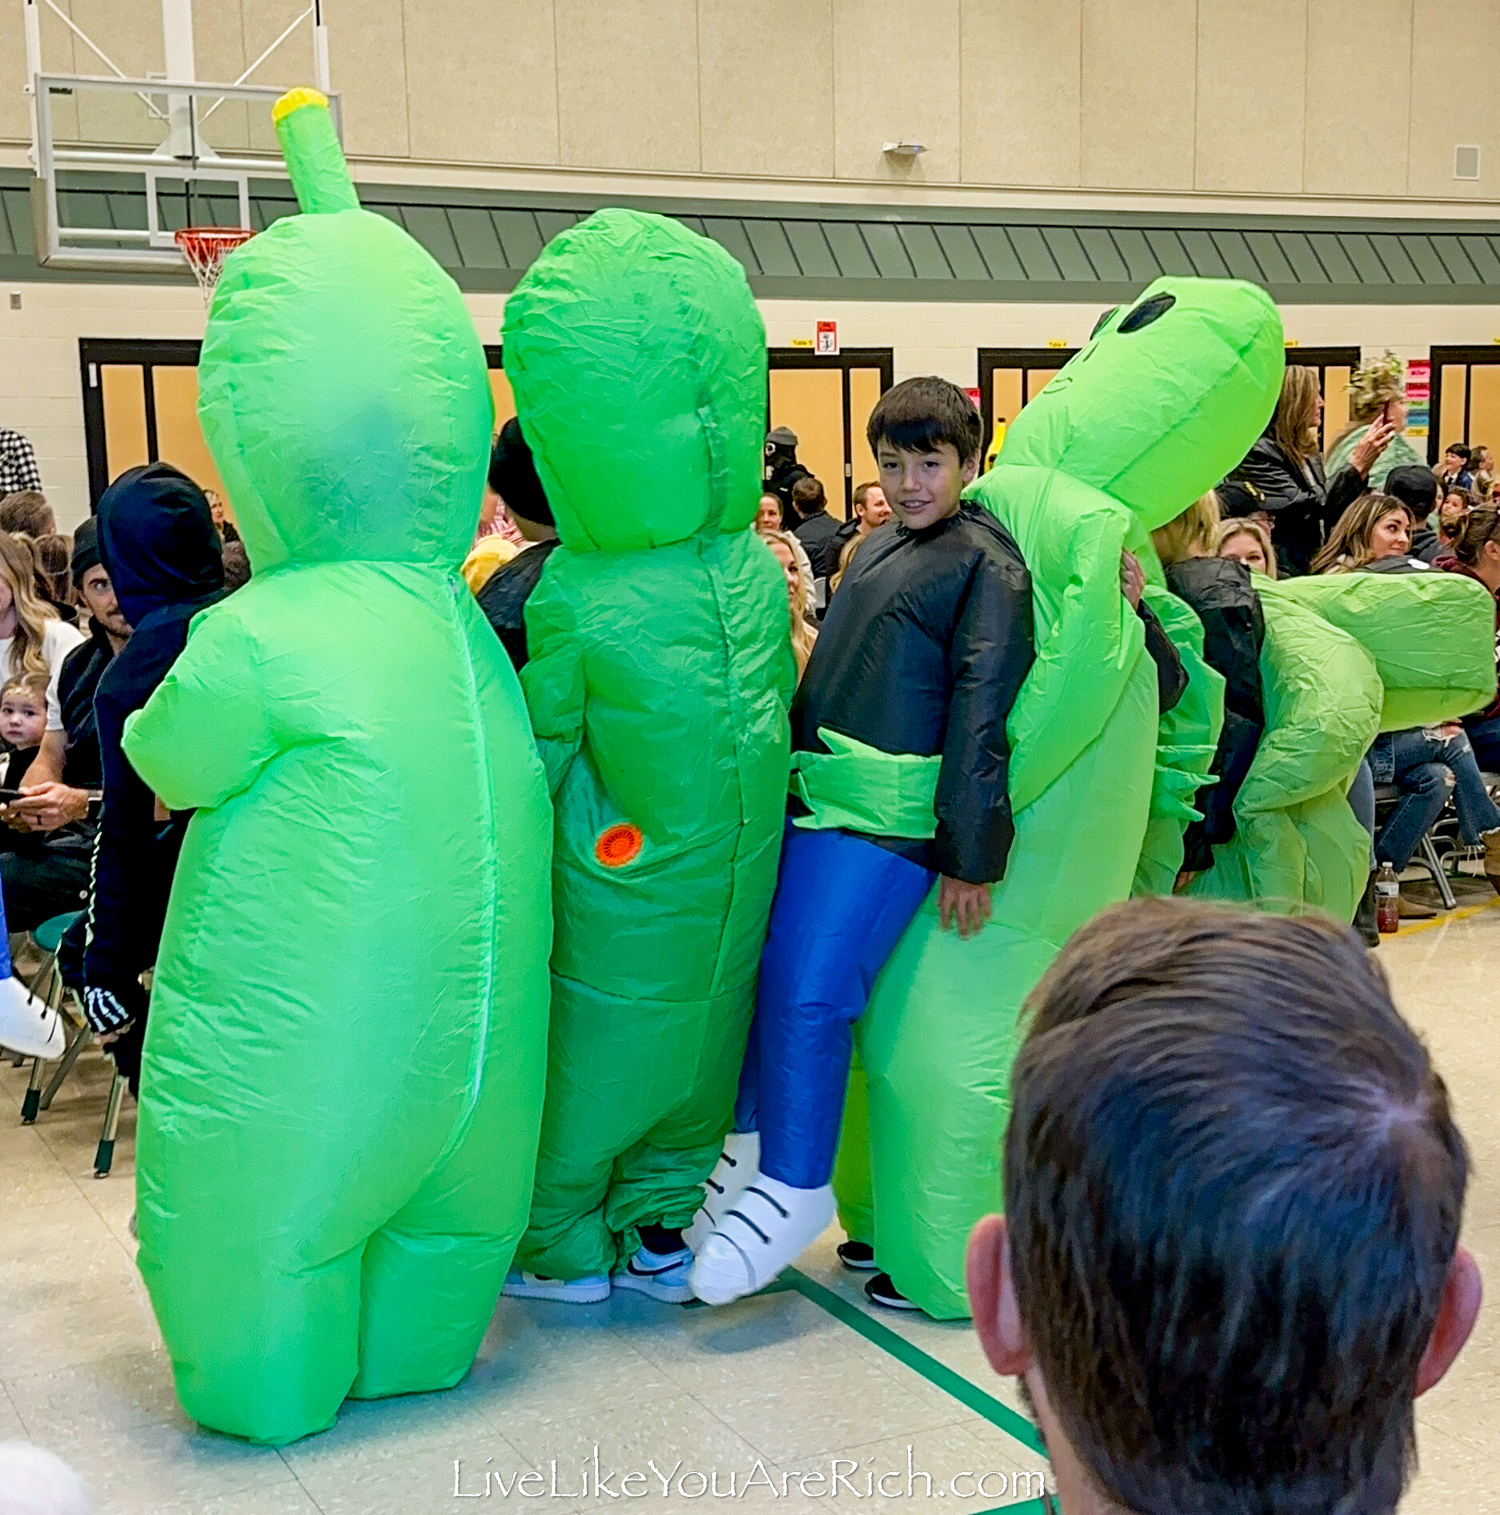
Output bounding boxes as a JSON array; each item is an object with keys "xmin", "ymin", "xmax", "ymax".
[{"xmin": 698, "ymin": 0, "xmax": 833, "ymax": 179}]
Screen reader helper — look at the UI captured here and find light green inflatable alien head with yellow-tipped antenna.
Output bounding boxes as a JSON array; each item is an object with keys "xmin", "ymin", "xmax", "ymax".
[{"xmin": 198, "ymin": 89, "xmax": 494, "ymax": 573}]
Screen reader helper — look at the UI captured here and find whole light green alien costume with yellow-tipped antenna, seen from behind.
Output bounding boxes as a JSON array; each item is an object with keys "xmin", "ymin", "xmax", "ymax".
[{"xmin": 126, "ymin": 95, "xmax": 552, "ymax": 1444}]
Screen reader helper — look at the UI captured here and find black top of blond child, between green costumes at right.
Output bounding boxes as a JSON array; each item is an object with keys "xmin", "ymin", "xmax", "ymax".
[{"xmin": 1167, "ymin": 558, "xmax": 1265, "ymax": 873}]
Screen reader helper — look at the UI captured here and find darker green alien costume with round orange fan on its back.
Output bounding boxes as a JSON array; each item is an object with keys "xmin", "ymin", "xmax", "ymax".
[{"xmin": 505, "ymin": 211, "xmax": 795, "ymax": 1279}]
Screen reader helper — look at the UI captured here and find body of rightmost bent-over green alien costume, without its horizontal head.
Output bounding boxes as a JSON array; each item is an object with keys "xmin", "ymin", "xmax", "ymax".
[{"xmin": 1188, "ymin": 596, "xmax": 1382, "ymax": 923}]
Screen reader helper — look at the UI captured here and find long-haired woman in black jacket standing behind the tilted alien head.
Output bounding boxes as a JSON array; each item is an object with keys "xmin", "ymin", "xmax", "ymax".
[{"xmin": 1230, "ymin": 367, "xmax": 1395, "ymax": 574}]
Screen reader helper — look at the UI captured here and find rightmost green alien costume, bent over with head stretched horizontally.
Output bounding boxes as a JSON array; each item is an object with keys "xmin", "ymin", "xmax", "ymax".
[{"xmin": 1189, "ymin": 573, "xmax": 1494, "ymax": 921}]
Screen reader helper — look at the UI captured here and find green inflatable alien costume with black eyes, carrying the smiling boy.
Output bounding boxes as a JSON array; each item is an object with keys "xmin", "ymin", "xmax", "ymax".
[{"xmin": 836, "ymin": 279, "xmax": 1285, "ymax": 1318}]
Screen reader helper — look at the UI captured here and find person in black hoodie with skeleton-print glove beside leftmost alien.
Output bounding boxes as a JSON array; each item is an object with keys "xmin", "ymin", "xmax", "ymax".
[{"xmin": 83, "ymin": 464, "xmax": 224, "ymax": 1094}]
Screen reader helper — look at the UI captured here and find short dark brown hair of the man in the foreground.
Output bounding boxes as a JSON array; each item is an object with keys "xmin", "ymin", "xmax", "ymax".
[{"xmin": 1005, "ymin": 900, "xmax": 1468, "ymax": 1515}]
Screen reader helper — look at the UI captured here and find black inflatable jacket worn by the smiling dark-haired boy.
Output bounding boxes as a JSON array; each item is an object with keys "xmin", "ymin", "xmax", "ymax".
[{"xmin": 791, "ymin": 504, "xmax": 1035, "ymax": 883}]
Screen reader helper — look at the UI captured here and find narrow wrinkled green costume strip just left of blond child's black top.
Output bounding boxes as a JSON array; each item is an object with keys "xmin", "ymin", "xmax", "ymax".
[{"xmin": 1130, "ymin": 585, "xmax": 1224, "ymax": 895}]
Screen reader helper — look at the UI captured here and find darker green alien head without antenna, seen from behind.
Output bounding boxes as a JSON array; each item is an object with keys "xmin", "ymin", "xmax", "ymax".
[{"xmin": 503, "ymin": 209, "xmax": 765, "ymax": 551}]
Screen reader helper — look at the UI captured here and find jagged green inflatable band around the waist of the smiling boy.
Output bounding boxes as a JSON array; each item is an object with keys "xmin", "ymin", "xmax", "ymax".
[{"xmin": 791, "ymin": 726, "xmax": 942, "ymax": 839}]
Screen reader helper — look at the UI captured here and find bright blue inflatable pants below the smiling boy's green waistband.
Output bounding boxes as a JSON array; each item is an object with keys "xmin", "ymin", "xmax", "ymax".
[{"xmin": 735, "ymin": 821, "xmax": 936, "ymax": 1189}]
